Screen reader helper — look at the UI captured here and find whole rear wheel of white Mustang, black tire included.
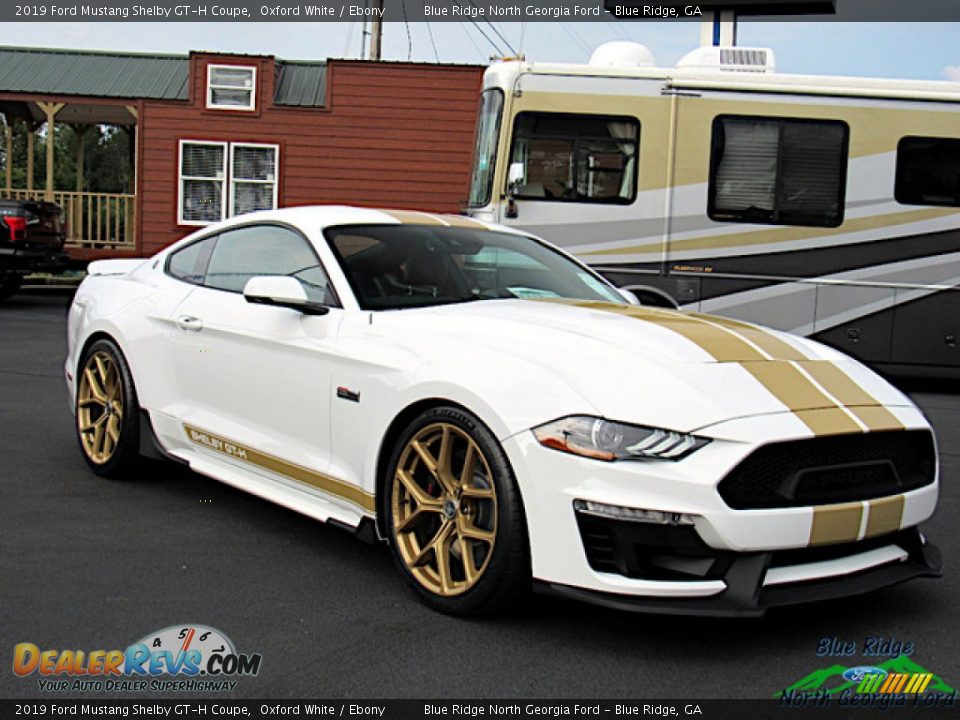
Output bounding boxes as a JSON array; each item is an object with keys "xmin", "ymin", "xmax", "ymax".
[{"xmin": 76, "ymin": 339, "xmax": 140, "ymax": 477}]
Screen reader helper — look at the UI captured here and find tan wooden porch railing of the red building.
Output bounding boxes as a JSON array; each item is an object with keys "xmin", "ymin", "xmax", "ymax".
[{"xmin": 0, "ymin": 188, "xmax": 137, "ymax": 249}]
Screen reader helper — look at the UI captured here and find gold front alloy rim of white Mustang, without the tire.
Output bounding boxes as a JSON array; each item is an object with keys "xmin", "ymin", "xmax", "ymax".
[{"xmin": 391, "ymin": 422, "xmax": 497, "ymax": 596}]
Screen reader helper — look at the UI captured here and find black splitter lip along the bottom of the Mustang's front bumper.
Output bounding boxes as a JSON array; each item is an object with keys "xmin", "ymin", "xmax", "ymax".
[{"xmin": 535, "ymin": 529, "xmax": 942, "ymax": 617}]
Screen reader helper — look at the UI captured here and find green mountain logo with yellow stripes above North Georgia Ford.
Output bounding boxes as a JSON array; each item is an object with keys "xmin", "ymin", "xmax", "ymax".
[{"xmin": 774, "ymin": 655, "xmax": 955, "ymax": 698}]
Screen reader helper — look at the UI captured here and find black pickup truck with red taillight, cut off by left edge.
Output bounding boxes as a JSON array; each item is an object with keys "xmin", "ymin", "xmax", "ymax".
[{"xmin": 0, "ymin": 198, "xmax": 68, "ymax": 302}]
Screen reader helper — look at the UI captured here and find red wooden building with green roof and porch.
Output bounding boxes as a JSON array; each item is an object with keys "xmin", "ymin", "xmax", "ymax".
[{"xmin": 0, "ymin": 48, "xmax": 483, "ymax": 259}]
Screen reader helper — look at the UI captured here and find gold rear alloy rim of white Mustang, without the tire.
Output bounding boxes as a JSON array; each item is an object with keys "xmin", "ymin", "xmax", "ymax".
[{"xmin": 77, "ymin": 350, "xmax": 123, "ymax": 465}]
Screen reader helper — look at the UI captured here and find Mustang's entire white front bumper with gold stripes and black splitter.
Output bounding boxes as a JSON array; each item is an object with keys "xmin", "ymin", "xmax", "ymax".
[{"xmin": 503, "ymin": 408, "xmax": 940, "ymax": 615}]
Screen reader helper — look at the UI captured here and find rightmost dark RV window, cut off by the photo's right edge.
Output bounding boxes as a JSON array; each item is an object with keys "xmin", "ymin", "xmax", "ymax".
[{"xmin": 894, "ymin": 137, "xmax": 960, "ymax": 207}]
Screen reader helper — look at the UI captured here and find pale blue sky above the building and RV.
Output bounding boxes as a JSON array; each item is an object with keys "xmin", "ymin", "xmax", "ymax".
[{"xmin": 5, "ymin": 21, "xmax": 960, "ymax": 81}]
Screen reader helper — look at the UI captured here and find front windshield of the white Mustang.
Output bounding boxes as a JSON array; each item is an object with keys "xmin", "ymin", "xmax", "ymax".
[{"xmin": 325, "ymin": 225, "xmax": 623, "ymax": 310}]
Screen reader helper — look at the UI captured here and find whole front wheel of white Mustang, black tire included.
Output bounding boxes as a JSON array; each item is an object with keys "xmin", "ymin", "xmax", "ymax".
[{"xmin": 384, "ymin": 407, "xmax": 530, "ymax": 615}]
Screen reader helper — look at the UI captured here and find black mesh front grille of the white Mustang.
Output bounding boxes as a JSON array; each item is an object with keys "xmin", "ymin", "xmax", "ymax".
[{"xmin": 717, "ymin": 430, "xmax": 936, "ymax": 510}]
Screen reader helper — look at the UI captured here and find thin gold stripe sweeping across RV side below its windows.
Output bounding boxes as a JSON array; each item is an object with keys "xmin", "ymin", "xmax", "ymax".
[{"xmin": 580, "ymin": 208, "xmax": 960, "ymax": 258}]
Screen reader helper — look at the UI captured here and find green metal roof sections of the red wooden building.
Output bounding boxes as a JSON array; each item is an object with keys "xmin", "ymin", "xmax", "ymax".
[{"xmin": 0, "ymin": 46, "xmax": 327, "ymax": 107}]
